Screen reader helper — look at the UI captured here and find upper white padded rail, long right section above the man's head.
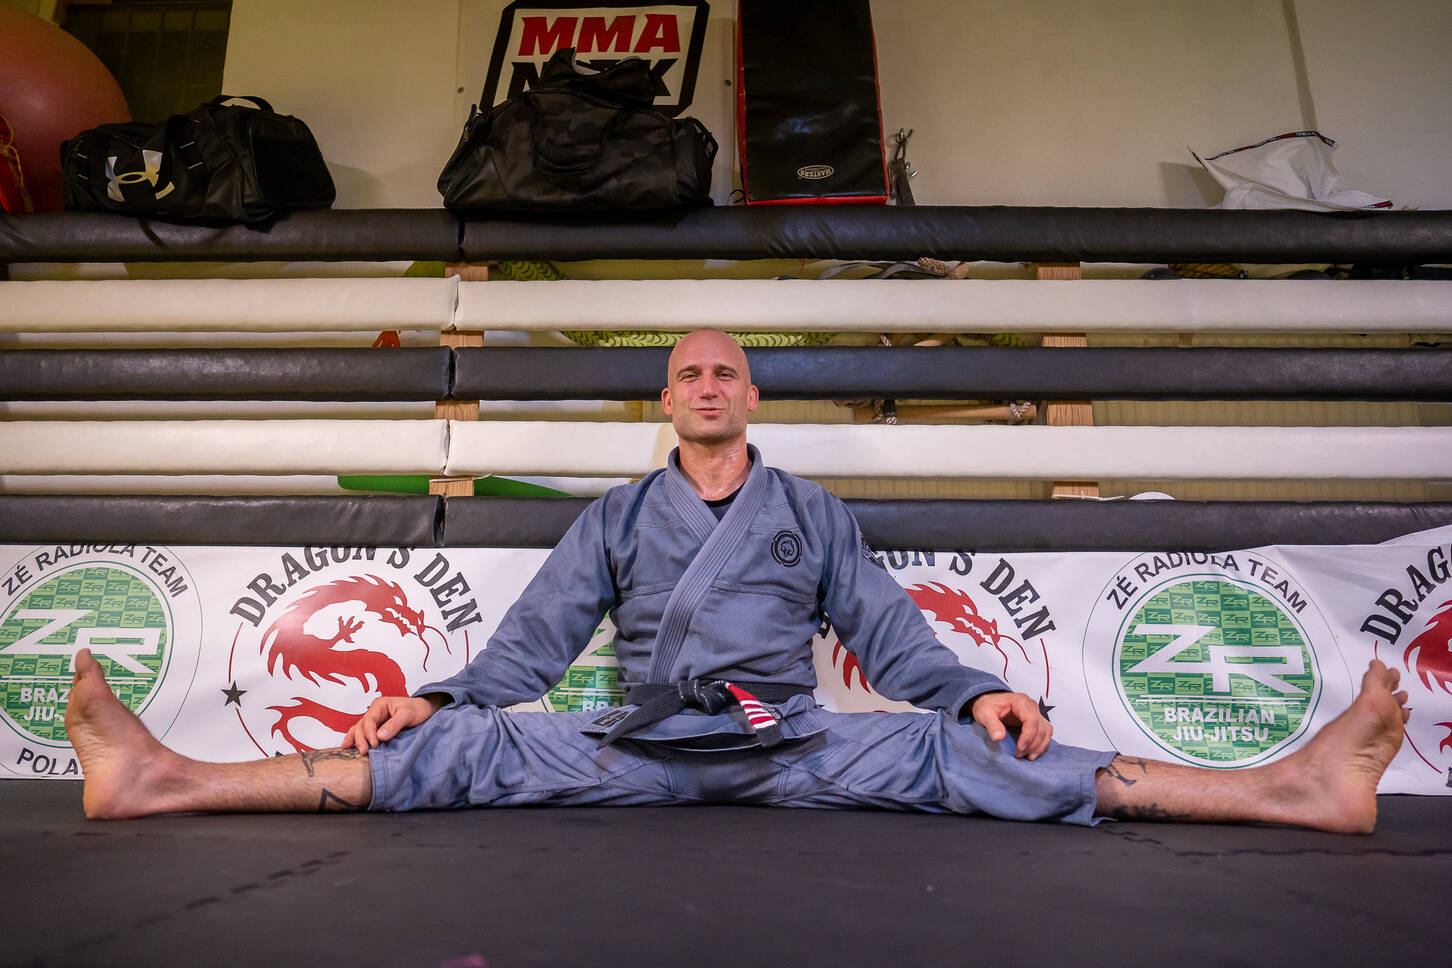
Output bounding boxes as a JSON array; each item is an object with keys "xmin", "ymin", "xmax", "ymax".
[{"xmin": 456, "ymin": 279, "xmax": 1452, "ymax": 332}]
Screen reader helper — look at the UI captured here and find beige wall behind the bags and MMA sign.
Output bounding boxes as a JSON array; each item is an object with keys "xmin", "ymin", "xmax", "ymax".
[{"xmin": 225, "ymin": 0, "xmax": 1452, "ymax": 209}]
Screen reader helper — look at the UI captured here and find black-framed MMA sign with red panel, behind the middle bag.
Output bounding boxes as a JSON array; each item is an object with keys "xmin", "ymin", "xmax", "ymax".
[{"xmin": 479, "ymin": 0, "xmax": 710, "ymax": 115}]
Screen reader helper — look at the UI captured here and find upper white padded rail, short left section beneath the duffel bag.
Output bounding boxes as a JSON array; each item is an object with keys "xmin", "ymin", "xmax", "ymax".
[{"xmin": 0, "ymin": 277, "xmax": 459, "ymax": 332}]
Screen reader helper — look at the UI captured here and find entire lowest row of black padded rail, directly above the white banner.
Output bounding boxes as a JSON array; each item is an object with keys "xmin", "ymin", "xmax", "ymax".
[{"xmin": 0, "ymin": 495, "xmax": 1452, "ymax": 551}]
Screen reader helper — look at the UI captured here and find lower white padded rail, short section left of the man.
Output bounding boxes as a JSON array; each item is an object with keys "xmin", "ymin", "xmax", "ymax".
[{"xmin": 0, "ymin": 419, "xmax": 449, "ymax": 475}]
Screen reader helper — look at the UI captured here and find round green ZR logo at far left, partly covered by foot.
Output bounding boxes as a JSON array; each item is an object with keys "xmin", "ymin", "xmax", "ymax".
[{"xmin": 0, "ymin": 565, "xmax": 170, "ymax": 745}]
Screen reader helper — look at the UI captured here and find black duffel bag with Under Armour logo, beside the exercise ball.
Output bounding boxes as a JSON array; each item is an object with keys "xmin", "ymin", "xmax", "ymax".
[{"xmin": 61, "ymin": 94, "xmax": 335, "ymax": 222}]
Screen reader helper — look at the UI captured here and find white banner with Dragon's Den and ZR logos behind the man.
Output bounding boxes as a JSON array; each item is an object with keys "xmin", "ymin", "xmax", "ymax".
[{"xmin": 0, "ymin": 527, "xmax": 1452, "ymax": 794}]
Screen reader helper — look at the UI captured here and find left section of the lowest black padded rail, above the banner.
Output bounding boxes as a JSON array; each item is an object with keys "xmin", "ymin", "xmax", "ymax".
[{"xmin": 0, "ymin": 495, "xmax": 443, "ymax": 547}]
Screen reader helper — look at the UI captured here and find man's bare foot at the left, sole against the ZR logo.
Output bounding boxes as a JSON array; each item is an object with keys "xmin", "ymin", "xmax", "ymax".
[{"xmin": 65, "ymin": 649, "xmax": 179, "ymax": 820}]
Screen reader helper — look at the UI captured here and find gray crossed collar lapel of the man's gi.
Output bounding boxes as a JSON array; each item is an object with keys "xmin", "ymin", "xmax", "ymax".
[{"xmin": 646, "ymin": 444, "xmax": 767, "ymax": 682}]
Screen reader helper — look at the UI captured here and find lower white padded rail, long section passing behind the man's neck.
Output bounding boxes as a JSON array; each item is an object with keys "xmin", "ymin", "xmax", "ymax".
[{"xmin": 447, "ymin": 421, "xmax": 1452, "ymax": 480}]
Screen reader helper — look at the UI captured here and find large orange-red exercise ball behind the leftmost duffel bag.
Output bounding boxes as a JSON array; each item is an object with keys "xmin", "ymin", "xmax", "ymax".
[{"xmin": 0, "ymin": 7, "xmax": 131, "ymax": 212}]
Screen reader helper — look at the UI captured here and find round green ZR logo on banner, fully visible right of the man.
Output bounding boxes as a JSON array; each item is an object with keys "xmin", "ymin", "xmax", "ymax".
[{"xmin": 1115, "ymin": 578, "xmax": 1318, "ymax": 766}]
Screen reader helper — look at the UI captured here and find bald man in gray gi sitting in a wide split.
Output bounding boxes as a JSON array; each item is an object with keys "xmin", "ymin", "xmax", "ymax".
[{"xmin": 65, "ymin": 331, "xmax": 1407, "ymax": 832}]
